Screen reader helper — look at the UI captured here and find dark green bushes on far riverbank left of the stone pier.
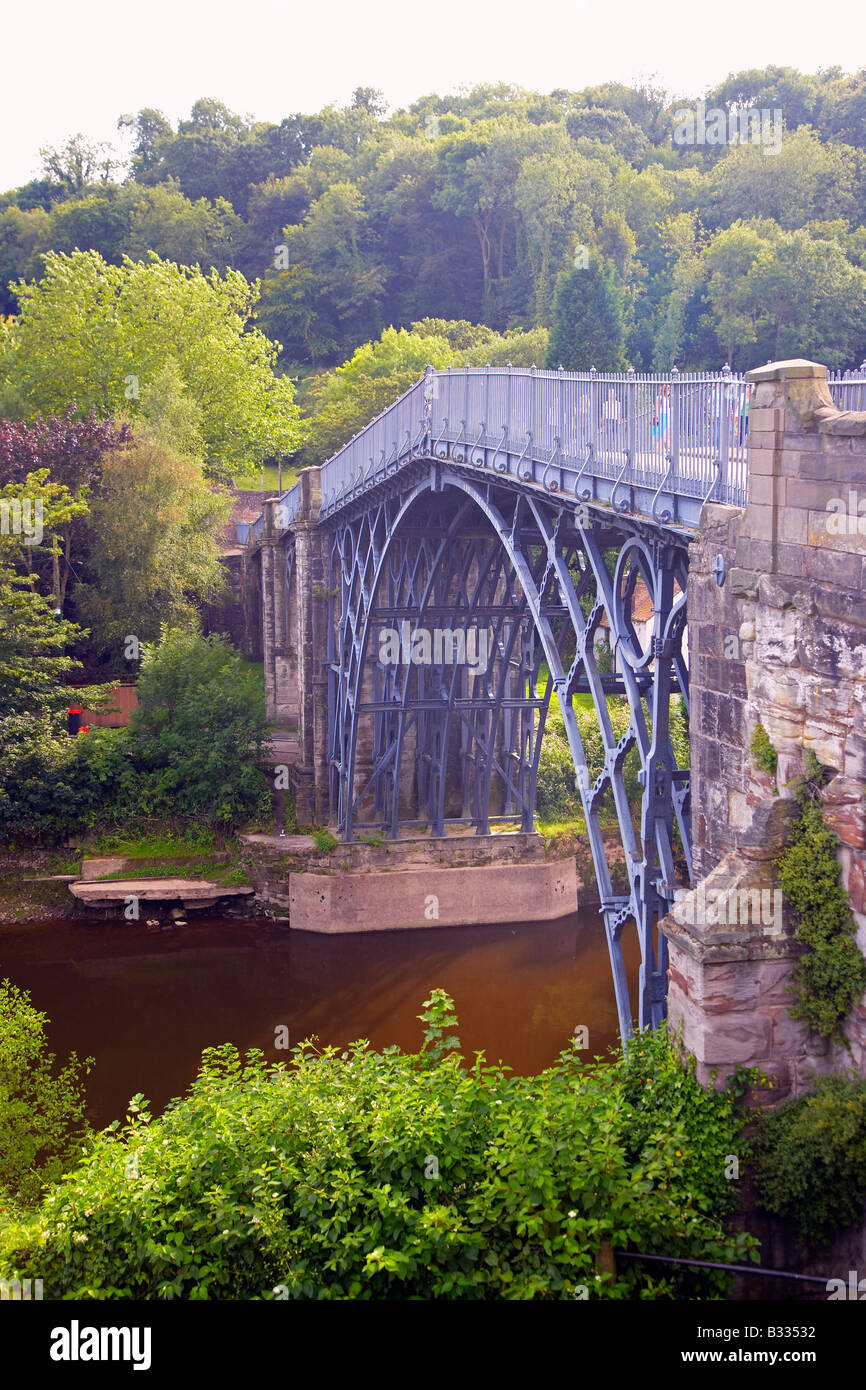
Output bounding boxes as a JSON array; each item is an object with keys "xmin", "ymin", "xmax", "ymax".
[{"xmin": 0, "ymin": 628, "xmax": 270, "ymax": 839}]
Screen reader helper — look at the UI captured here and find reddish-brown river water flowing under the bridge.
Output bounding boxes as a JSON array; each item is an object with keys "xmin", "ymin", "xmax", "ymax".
[{"xmin": 0, "ymin": 908, "xmax": 638, "ymax": 1127}]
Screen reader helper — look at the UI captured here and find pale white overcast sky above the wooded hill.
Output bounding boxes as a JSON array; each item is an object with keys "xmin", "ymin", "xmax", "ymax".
[{"xmin": 0, "ymin": 0, "xmax": 866, "ymax": 189}]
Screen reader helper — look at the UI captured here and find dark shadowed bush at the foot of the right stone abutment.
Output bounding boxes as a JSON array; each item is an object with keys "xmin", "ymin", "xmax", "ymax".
[{"xmin": 758, "ymin": 1076, "xmax": 866, "ymax": 1245}]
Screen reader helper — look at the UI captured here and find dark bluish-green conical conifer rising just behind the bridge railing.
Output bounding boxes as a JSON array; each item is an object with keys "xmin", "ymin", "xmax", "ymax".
[{"xmin": 548, "ymin": 254, "xmax": 626, "ymax": 371}]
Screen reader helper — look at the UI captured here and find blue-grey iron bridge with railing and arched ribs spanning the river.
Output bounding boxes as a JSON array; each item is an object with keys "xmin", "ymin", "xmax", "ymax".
[{"xmin": 268, "ymin": 368, "xmax": 748, "ymax": 1038}]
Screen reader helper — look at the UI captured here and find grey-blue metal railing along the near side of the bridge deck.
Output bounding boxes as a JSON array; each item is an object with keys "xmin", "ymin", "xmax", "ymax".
[{"xmin": 321, "ymin": 367, "xmax": 749, "ymax": 516}]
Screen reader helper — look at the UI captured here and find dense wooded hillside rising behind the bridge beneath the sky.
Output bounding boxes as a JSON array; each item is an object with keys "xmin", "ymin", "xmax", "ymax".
[{"xmin": 0, "ymin": 76, "xmax": 866, "ymax": 372}]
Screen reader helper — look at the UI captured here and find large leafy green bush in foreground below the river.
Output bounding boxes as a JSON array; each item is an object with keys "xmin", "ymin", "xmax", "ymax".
[{"xmin": 0, "ymin": 991, "xmax": 755, "ymax": 1300}]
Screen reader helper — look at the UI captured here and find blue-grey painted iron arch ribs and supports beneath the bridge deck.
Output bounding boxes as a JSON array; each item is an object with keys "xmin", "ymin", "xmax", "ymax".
[{"xmin": 322, "ymin": 461, "xmax": 691, "ymax": 1037}]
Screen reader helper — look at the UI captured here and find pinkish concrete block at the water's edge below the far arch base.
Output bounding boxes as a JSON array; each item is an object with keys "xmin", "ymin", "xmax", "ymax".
[{"xmin": 289, "ymin": 858, "xmax": 577, "ymax": 934}]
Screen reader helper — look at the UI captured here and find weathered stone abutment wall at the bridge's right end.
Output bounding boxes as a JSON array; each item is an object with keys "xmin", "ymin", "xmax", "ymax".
[{"xmin": 664, "ymin": 361, "xmax": 866, "ymax": 1094}]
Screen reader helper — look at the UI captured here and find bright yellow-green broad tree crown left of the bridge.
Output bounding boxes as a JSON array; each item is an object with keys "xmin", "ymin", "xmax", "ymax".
[{"xmin": 0, "ymin": 252, "xmax": 302, "ymax": 481}]
